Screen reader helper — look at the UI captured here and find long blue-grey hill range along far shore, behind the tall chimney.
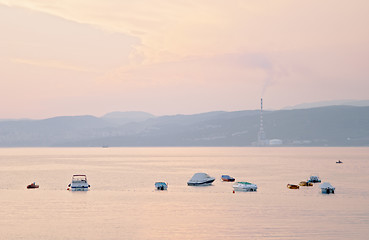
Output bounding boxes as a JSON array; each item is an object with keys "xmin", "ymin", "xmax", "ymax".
[{"xmin": 0, "ymin": 106, "xmax": 369, "ymax": 147}]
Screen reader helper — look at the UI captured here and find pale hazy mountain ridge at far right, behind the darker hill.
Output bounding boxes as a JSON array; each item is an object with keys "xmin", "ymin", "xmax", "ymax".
[{"xmin": 283, "ymin": 99, "xmax": 369, "ymax": 110}]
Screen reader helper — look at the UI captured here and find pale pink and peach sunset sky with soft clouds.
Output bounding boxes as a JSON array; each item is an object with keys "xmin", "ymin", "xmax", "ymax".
[{"xmin": 0, "ymin": 0, "xmax": 369, "ymax": 119}]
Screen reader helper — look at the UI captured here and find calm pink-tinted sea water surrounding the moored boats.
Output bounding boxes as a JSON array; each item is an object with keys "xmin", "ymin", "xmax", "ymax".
[{"xmin": 0, "ymin": 147, "xmax": 369, "ymax": 240}]
